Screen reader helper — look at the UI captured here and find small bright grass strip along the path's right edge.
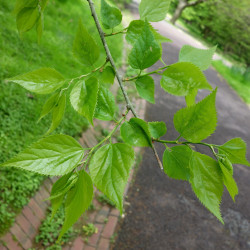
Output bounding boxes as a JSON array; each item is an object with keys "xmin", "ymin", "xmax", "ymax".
[{"xmin": 212, "ymin": 61, "xmax": 250, "ymax": 104}]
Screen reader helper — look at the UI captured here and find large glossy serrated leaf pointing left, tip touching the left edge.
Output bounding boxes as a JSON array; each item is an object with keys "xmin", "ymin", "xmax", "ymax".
[{"xmin": 0, "ymin": 135, "xmax": 84, "ymax": 176}]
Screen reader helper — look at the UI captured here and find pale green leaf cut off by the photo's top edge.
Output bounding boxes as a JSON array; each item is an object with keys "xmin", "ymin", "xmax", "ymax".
[{"xmin": 139, "ymin": 0, "xmax": 171, "ymax": 22}]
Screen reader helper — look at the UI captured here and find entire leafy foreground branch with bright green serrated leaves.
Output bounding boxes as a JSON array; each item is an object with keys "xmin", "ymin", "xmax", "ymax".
[{"xmin": 2, "ymin": 0, "xmax": 250, "ymax": 244}]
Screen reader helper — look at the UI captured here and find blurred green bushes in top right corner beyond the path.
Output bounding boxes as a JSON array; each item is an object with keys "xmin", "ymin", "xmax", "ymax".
[{"xmin": 171, "ymin": 0, "xmax": 250, "ymax": 66}]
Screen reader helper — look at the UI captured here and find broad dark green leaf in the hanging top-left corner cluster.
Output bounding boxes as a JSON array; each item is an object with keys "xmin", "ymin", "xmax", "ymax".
[{"xmin": 16, "ymin": 7, "xmax": 40, "ymax": 34}]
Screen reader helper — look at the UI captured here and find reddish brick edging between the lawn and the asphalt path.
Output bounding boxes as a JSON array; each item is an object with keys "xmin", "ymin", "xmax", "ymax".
[{"xmin": 0, "ymin": 96, "xmax": 145, "ymax": 250}]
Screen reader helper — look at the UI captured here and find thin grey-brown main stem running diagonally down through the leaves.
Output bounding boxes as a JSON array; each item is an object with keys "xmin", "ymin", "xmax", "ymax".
[{"xmin": 87, "ymin": 0, "xmax": 163, "ymax": 170}]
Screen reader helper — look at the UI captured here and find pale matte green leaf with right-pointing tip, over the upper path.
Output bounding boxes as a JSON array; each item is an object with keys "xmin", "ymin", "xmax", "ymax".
[{"xmin": 179, "ymin": 45, "xmax": 217, "ymax": 70}]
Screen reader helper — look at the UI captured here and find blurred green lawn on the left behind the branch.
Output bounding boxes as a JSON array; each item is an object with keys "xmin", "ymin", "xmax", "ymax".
[{"xmin": 0, "ymin": 0, "xmax": 123, "ymax": 235}]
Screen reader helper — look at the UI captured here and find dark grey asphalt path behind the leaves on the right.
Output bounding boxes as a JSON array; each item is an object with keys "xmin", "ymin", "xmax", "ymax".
[{"xmin": 114, "ymin": 2, "xmax": 250, "ymax": 250}]
